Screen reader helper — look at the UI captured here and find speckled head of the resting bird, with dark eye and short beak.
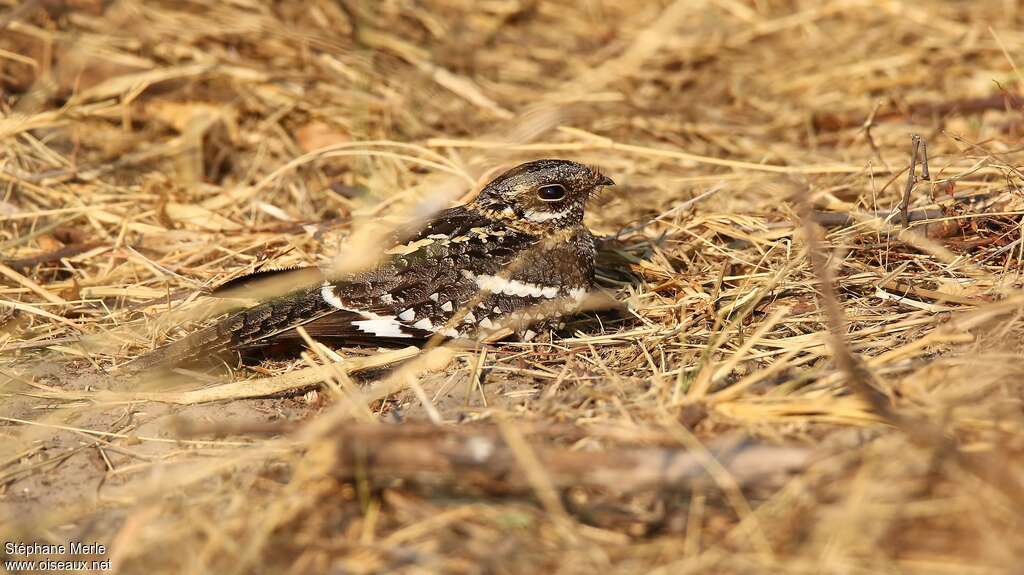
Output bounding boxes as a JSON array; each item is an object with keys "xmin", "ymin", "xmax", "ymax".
[{"xmin": 473, "ymin": 160, "xmax": 615, "ymax": 230}]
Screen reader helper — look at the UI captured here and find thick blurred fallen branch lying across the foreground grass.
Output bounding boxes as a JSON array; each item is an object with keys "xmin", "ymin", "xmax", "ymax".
[{"xmin": 323, "ymin": 424, "xmax": 812, "ymax": 494}]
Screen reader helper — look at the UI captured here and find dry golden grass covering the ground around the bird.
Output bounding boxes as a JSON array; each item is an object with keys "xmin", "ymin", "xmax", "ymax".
[{"xmin": 0, "ymin": 0, "xmax": 1024, "ymax": 573}]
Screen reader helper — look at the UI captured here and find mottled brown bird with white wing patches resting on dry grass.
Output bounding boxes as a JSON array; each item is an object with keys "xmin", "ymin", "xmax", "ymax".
[{"xmin": 126, "ymin": 159, "xmax": 614, "ymax": 370}]
